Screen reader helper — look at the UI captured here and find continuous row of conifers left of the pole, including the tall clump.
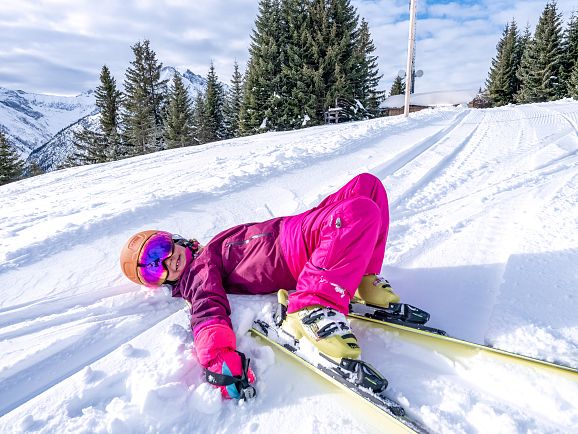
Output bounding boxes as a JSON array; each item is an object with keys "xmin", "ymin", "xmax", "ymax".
[{"xmin": 65, "ymin": 0, "xmax": 383, "ymax": 166}]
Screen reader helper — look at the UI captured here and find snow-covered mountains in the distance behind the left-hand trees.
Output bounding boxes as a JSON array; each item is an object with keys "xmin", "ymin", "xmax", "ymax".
[{"xmin": 0, "ymin": 66, "xmax": 207, "ymax": 171}]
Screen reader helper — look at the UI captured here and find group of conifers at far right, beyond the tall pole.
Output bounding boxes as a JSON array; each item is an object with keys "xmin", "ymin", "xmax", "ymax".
[{"xmin": 485, "ymin": 1, "xmax": 578, "ymax": 106}]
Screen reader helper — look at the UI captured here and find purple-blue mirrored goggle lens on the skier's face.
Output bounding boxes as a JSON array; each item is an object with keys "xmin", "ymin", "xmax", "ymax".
[{"xmin": 137, "ymin": 231, "xmax": 174, "ymax": 286}]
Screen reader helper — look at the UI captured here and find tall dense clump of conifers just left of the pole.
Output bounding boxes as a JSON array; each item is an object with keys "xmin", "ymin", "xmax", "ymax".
[{"xmin": 241, "ymin": 0, "xmax": 383, "ymax": 128}]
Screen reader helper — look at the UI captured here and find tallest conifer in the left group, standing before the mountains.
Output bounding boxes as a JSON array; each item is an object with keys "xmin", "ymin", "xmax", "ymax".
[{"xmin": 123, "ymin": 40, "xmax": 167, "ymax": 155}]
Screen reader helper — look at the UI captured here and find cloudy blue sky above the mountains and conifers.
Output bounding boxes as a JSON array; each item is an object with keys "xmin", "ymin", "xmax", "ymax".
[{"xmin": 0, "ymin": 0, "xmax": 578, "ymax": 95}]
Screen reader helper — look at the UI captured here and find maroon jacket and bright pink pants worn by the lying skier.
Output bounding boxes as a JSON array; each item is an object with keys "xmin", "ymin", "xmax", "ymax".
[{"xmin": 173, "ymin": 173, "xmax": 389, "ymax": 335}]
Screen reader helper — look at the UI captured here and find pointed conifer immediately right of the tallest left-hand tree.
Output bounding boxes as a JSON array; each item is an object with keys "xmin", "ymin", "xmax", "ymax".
[{"xmin": 165, "ymin": 73, "xmax": 198, "ymax": 149}]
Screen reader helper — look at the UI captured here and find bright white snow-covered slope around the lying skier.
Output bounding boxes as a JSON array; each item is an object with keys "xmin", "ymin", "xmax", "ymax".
[{"xmin": 0, "ymin": 101, "xmax": 578, "ymax": 434}]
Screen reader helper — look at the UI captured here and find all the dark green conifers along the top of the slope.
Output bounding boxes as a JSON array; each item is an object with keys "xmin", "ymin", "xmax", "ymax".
[{"xmin": 0, "ymin": 0, "xmax": 578, "ymax": 185}]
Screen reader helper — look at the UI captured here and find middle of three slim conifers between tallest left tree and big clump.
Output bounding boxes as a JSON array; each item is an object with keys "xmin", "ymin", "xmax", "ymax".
[{"xmin": 198, "ymin": 62, "xmax": 225, "ymax": 143}]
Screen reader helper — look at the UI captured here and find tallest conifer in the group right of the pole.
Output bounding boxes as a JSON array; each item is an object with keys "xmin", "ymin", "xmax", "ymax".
[{"xmin": 516, "ymin": 1, "xmax": 564, "ymax": 103}]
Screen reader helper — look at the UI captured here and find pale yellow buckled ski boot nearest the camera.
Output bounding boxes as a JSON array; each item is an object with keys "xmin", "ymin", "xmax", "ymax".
[{"xmin": 275, "ymin": 289, "xmax": 361, "ymax": 361}]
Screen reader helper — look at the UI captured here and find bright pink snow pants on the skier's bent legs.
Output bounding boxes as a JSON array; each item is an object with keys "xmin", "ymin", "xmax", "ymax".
[{"xmin": 281, "ymin": 173, "xmax": 389, "ymax": 314}]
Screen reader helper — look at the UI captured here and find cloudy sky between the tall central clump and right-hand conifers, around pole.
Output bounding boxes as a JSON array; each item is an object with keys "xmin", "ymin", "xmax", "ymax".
[{"xmin": 352, "ymin": 0, "xmax": 578, "ymax": 92}]
